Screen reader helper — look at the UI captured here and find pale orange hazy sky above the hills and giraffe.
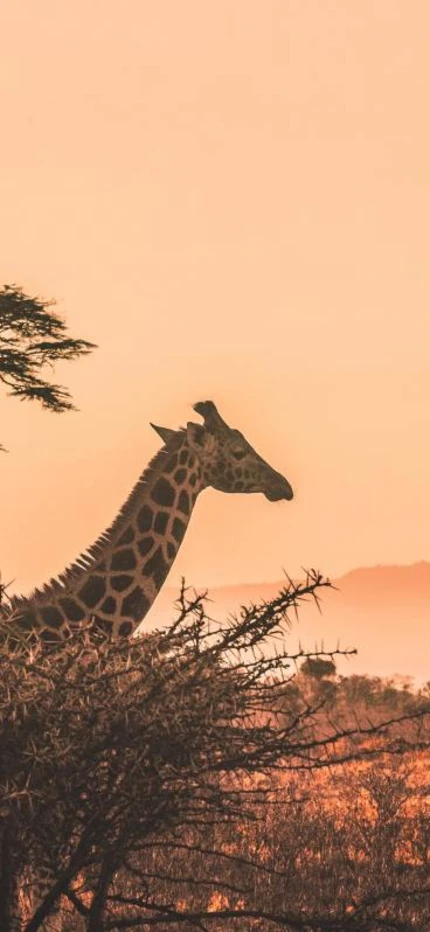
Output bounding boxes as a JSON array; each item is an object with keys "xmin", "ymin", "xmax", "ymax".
[{"xmin": 0, "ymin": 0, "xmax": 430, "ymax": 591}]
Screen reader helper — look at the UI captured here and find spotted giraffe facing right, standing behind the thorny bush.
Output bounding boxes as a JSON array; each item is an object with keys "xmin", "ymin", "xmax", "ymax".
[{"xmin": 5, "ymin": 401, "xmax": 293, "ymax": 642}]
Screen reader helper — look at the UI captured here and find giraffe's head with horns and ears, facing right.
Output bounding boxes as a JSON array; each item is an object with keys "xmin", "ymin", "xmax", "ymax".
[{"xmin": 152, "ymin": 401, "xmax": 293, "ymax": 502}]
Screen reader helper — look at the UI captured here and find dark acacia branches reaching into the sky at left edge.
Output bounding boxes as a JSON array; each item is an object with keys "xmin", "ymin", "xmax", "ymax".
[{"xmin": 0, "ymin": 285, "xmax": 95, "ymax": 449}]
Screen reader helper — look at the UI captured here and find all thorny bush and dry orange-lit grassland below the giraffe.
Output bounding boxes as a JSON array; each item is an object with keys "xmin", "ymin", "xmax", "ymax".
[{"xmin": 0, "ymin": 572, "xmax": 430, "ymax": 932}]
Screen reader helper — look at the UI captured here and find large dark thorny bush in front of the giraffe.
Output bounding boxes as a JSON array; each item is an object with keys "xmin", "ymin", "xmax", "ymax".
[{"xmin": 0, "ymin": 572, "xmax": 428, "ymax": 932}]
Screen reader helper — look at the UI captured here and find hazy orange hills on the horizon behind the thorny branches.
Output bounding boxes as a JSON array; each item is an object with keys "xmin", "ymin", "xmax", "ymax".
[{"xmin": 148, "ymin": 561, "xmax": 430, "ymax": 685}]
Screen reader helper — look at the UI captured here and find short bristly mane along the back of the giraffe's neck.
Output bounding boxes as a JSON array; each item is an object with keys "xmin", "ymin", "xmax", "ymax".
[{"xmin": 7, "ymin": 427, "xmax": 186, "ymax": 618}]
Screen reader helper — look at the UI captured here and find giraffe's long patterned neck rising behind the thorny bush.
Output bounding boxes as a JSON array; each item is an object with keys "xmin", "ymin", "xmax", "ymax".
[{"xmin": 9, "ymin": 432, "xmax": 204, "ymax": 640}]
